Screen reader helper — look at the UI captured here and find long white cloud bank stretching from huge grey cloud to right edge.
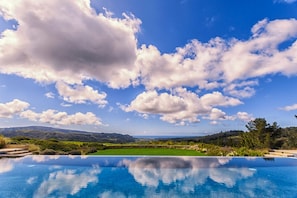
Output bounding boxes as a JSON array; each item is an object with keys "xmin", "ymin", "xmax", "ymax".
[{"xmin": 137, "ymin": 19, "xmax": 297, "ymax": 90}]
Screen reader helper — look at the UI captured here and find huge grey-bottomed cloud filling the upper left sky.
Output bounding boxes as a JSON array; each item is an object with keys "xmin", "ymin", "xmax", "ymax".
[{"xmin": 0, "ymin": 0, "xmax": 141, "ymax": 88}]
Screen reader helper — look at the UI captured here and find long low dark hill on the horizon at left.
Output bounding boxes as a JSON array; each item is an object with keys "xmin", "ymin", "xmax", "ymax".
[{"xmin": 0, "ymin": 126, "xmax": 136, "ymax": 143}]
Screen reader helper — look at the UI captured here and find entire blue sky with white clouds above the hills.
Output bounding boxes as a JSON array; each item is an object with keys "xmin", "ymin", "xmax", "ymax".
[{"xmin": 0, "ymin": 0, "xmax": 297, "ymax": 136}]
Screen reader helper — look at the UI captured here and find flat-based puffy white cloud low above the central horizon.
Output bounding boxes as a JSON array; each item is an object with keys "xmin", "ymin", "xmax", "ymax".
[{"xmin": 121, "ymin": 88, "xmax": 242, "ymax": 125}]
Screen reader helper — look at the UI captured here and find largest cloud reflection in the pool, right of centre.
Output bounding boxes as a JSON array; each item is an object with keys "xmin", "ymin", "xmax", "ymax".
[{"xmin": 123, "ymin": 157, "xmax": 255, "ymax": 191}]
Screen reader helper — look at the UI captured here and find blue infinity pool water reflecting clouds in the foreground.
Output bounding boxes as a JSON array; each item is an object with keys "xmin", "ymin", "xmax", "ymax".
[{"xmin": 0, "ymin": 155, "xmax": 297, "ymax": 198}]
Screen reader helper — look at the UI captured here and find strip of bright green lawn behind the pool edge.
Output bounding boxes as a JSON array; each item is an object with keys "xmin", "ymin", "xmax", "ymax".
[{"xmin": 90, "ymin": 148, "xmax": 205, "ymax": 156}]
